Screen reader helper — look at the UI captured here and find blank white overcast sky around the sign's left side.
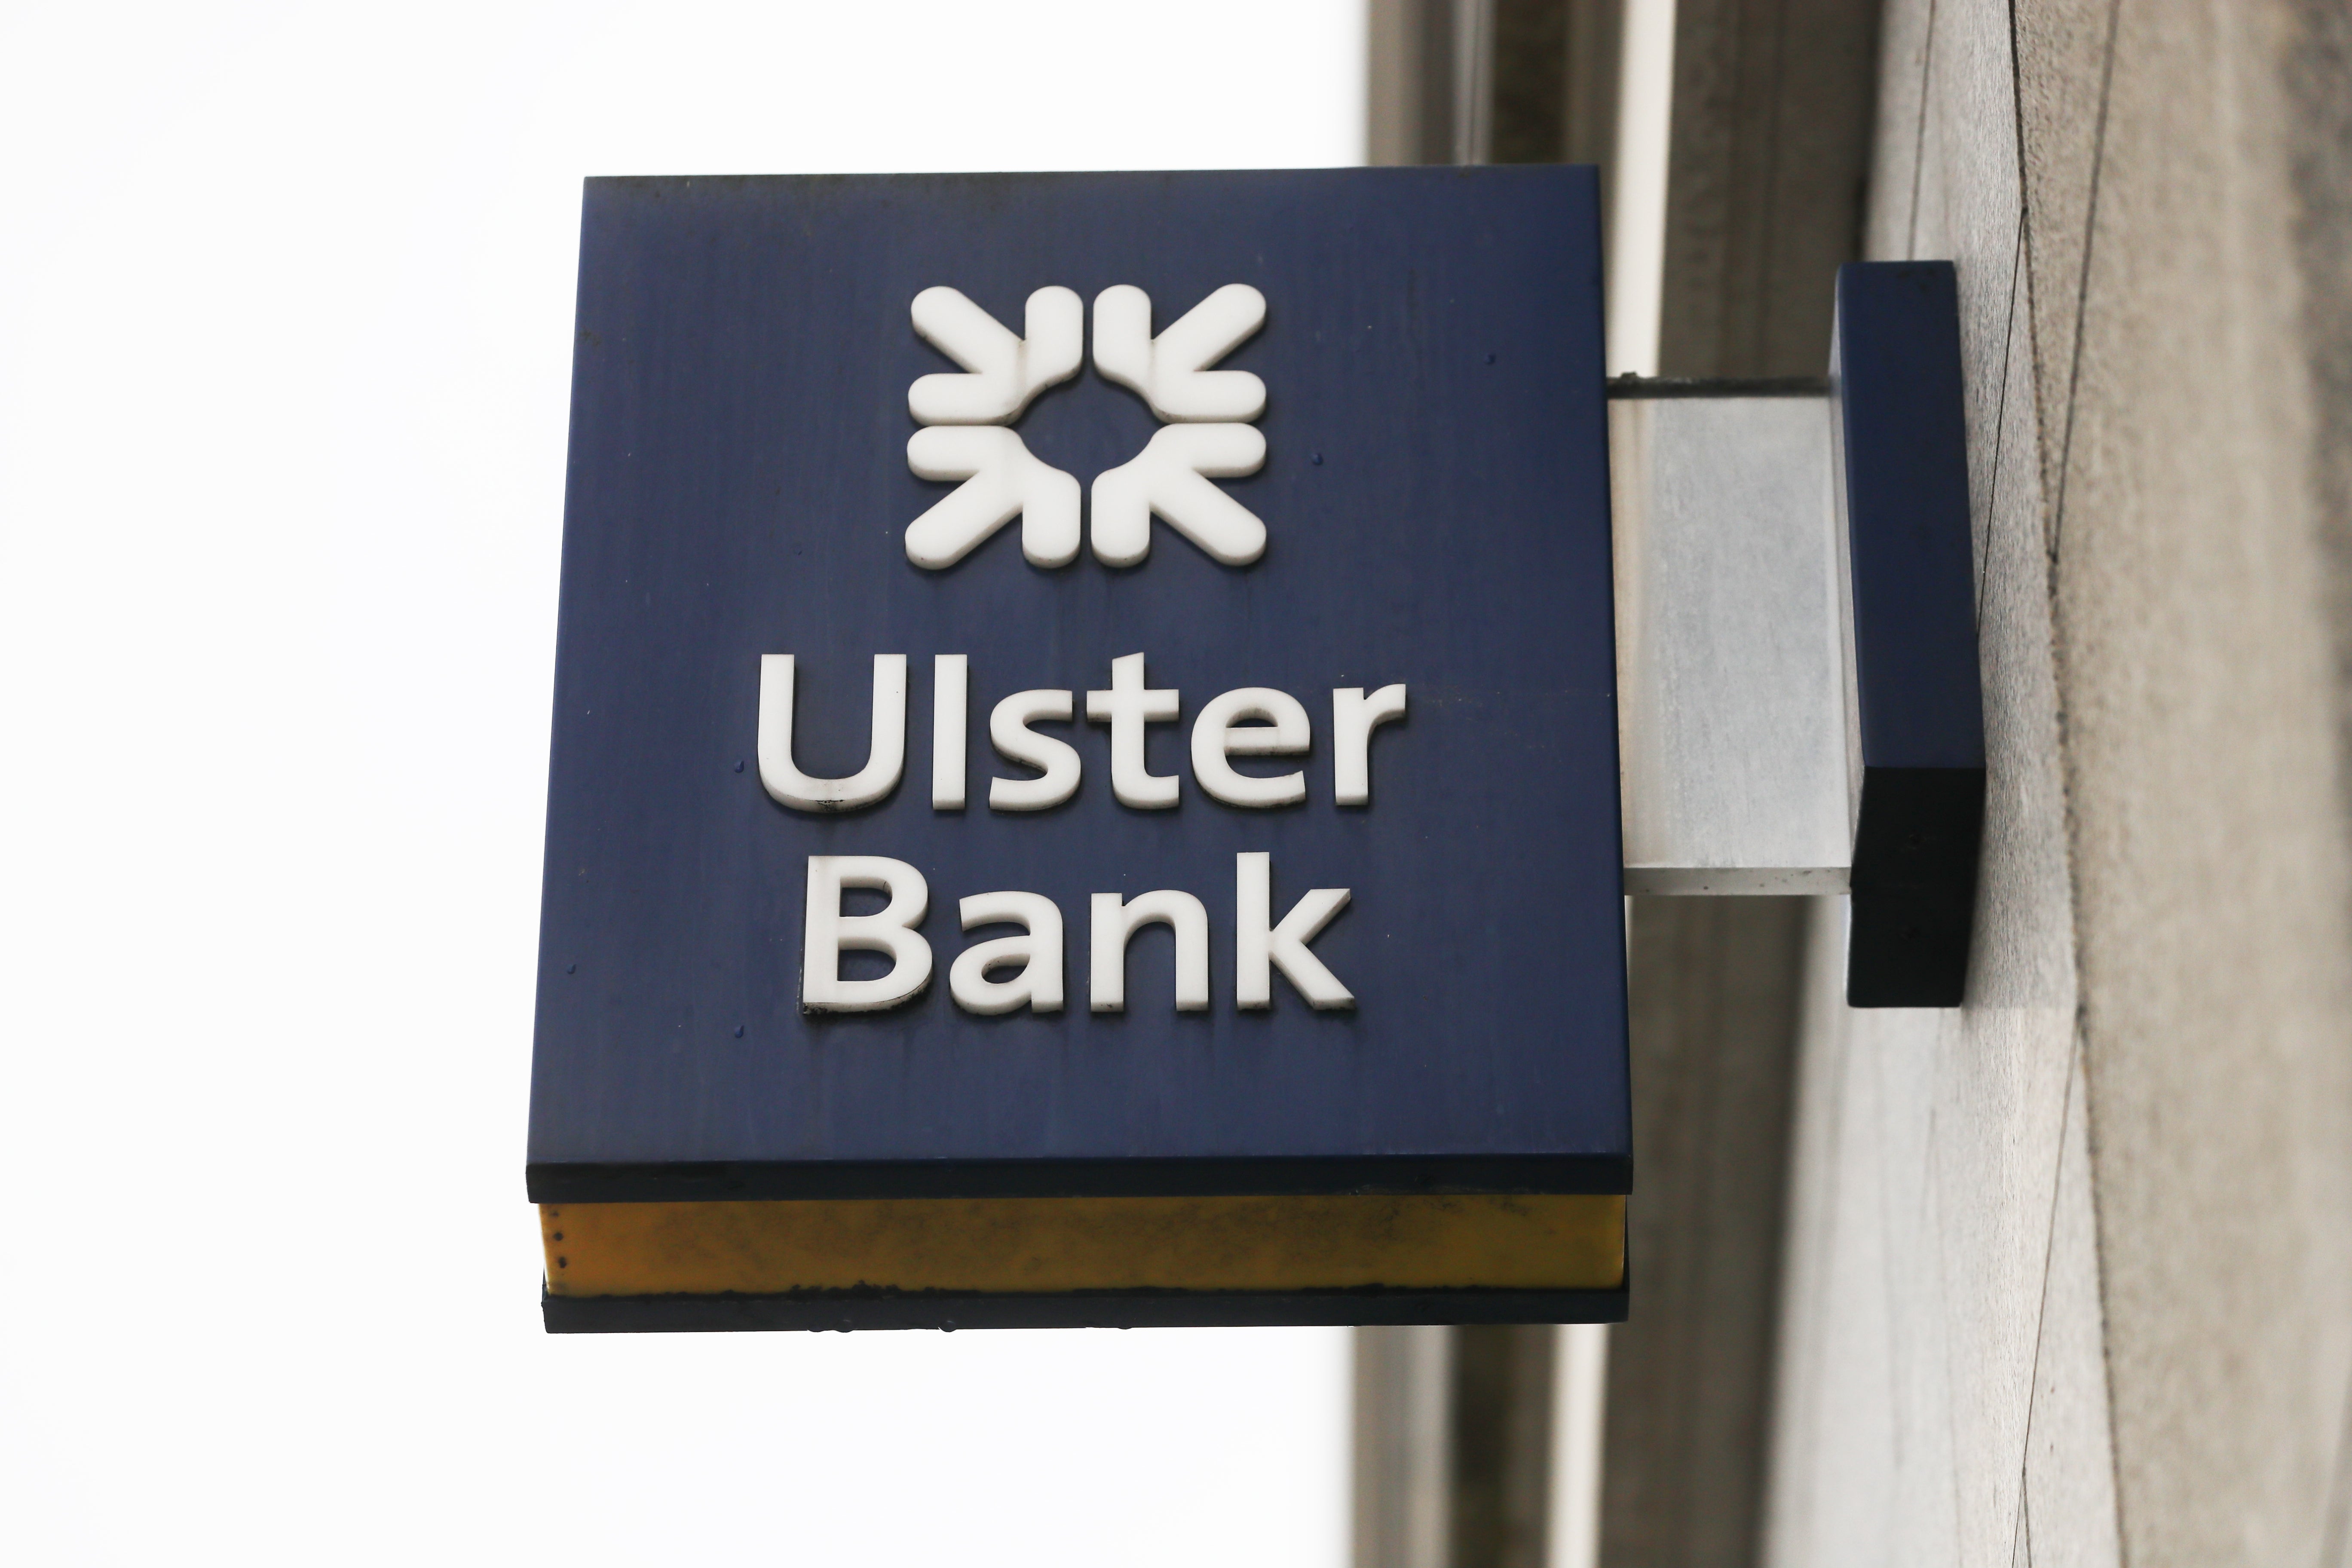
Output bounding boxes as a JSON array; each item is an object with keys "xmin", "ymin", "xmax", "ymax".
[{"xmin": 0, "ymin": 0, "xmax": 1362, "ymax": 1568}]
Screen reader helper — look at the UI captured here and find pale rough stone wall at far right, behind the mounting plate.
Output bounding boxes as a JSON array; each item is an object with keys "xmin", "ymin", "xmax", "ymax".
[{"xmin": 1766, "ymin": 0, "xmax": 2352, "ymax": 1568}]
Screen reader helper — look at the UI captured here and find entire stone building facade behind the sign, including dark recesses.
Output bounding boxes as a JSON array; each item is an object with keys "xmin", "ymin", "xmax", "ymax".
[{"xmin": 1357, "ymin": 0, "xmax": 2352, "ymax": 1568}]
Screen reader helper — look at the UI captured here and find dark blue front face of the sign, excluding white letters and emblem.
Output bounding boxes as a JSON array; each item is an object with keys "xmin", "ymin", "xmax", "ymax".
[{"xmin": 529, "ymin": 169, "xmax": 1630, "ymax": 1201}]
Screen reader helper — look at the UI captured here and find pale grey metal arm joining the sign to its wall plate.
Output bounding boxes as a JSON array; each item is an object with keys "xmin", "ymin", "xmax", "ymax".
[{"xmin": 1609, "ymin": 381, "xmax": 1853, "ymax": 893}]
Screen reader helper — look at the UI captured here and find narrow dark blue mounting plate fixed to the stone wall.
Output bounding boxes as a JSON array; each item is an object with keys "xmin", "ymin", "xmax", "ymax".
[{"xmin": 1830, "ymin": 261, "xmax": 1985, "ymax": 1006}]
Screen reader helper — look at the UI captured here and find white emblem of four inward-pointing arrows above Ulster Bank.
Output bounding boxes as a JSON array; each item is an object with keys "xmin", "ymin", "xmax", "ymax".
[{"xmin": 906, "ymin": 282, "xmax": 1265, "ymax": 571}]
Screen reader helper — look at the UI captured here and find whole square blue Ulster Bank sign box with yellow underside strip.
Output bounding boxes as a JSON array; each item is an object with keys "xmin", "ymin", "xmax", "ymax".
[{"xmin": 529, "ymin": 169, "xmax": 1630, "ymax": 1328}]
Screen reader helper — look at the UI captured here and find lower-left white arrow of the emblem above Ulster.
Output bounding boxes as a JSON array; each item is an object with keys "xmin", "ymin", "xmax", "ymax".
[{"xmin": 906, "ymin": 425, "xmax": 1087, "ymax": 571}]
